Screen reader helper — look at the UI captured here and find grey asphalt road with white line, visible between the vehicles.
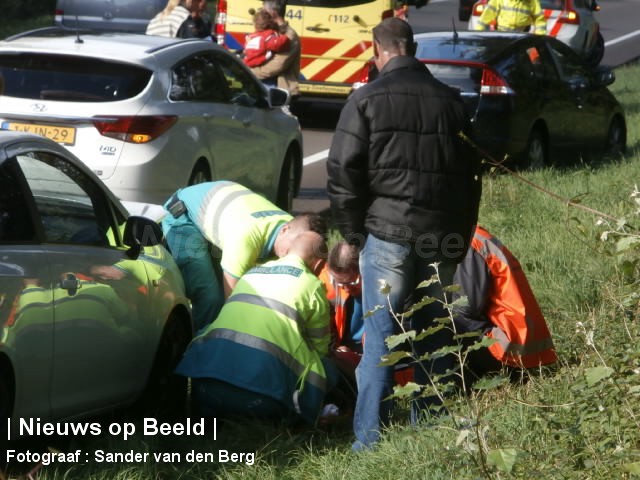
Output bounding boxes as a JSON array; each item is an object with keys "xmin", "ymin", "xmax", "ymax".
[{"xmin": 294, "ymin": 0, "xmax": 640, "ymax": 212}]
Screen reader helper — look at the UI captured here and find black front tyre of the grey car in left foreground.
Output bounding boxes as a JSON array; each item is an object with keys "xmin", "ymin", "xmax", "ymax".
[{"xmin": 138, "ymin": 313, "xmax": 192, "ymax": 418}]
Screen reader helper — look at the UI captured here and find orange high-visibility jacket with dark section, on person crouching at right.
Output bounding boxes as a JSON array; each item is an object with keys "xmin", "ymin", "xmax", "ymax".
[{"xmin": 455, "ymin": 226, "xmax": 557, "ymax": 368}]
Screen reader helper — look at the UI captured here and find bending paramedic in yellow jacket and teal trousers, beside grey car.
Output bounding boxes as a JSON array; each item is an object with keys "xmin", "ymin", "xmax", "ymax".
[{"xmin": 162, "ymin": 181, "xmax": 325, "ymax": 331}]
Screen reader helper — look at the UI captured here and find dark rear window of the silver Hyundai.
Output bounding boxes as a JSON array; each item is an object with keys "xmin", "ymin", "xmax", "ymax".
[{"xmin": 0, "ymin": 53, "xmax": 152, "ymax": 102}]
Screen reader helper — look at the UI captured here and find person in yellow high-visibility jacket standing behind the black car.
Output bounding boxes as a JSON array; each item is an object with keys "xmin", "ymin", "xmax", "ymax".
[{"xmin": 476, "ymin": 0, "xmax": 547, "ymax": 35}]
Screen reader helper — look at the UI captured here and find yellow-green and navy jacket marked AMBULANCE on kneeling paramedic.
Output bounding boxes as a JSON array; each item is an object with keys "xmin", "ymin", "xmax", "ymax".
[{"xmin": 176, "ymin": 255, "xmax": 330, "ymax": 423}]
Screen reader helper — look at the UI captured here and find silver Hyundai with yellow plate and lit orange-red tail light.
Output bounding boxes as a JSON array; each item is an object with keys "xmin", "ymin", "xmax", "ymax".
[{"xmin": 0, "ymin": 27, "xmax": 302, "ymax": 210}]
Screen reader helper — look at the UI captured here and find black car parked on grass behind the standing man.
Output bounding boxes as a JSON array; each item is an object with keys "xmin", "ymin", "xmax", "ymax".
[{"xmin": 354, "ymin": 32, "xmax": 627, "ymax": 167}]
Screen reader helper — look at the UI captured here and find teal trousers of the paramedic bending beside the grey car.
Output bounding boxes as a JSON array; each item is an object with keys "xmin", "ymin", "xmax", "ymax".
[{"xmin": 162, "ymin": 213, "xmax": 224, "ymax": 332}]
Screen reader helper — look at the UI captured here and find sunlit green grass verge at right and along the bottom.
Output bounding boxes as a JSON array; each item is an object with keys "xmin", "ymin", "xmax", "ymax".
[{"xmin": 0, "ymin": 16, "xmax": 640, "ymax": 480}]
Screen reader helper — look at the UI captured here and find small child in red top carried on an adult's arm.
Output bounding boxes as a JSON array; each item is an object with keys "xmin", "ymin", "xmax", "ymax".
[{"xmin": 244, "ymin": 9, "xmax": 289, "ymax": 73}]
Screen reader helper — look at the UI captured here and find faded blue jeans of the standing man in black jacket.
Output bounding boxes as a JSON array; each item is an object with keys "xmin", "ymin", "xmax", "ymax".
[{"xmin": 353, "ymin": 235, "xmax": 456, "ymax": 450}]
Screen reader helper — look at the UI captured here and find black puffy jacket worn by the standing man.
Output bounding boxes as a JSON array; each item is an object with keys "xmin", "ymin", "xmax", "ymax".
[{"xmin": 327, "ymin": 56, "xmax": 481, "ymax": 261}]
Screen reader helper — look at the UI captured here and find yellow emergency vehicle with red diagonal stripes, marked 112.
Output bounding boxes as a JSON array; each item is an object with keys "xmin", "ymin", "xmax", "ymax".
[{"xmin": 215, "ymin": 0, "xmax": 400, "ymax": 97}]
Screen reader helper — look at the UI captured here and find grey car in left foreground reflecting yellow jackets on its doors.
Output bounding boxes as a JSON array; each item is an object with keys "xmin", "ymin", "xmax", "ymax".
[{"xmin": 0, "ymin": 131, "xmax": 192, "ymax": 439}]
